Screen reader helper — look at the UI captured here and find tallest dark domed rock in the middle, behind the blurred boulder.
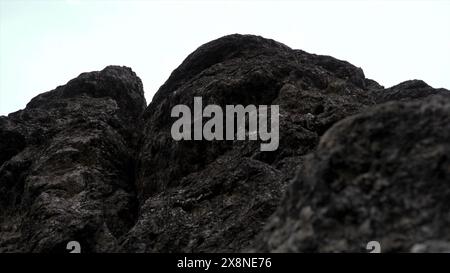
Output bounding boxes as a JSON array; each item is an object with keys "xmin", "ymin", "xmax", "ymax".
[{"xmin": 123, "ymin": 35, "xmax": 375, "ymax": 252}]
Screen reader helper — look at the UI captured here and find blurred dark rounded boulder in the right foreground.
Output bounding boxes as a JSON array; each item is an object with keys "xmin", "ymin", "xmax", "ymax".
[{"xmin": 256, "ymin": 95, "xmax": 450, "ymax": 252}]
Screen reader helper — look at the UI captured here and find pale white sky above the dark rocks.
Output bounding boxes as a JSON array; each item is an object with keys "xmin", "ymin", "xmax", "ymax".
[{"xmin": 0, "ymin": 0, "xmax": 450, "ymax": 115}]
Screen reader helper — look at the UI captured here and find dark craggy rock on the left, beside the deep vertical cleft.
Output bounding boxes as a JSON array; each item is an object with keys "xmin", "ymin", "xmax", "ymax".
[{"xmin": 0, "ymin": 66, "xmax": 146, "ymax": 252}]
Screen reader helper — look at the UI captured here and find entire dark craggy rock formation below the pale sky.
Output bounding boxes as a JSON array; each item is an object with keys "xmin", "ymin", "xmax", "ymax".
[{"xmin": 0, "ymin": 35, "xmax": 449, "ymax": 252}]
